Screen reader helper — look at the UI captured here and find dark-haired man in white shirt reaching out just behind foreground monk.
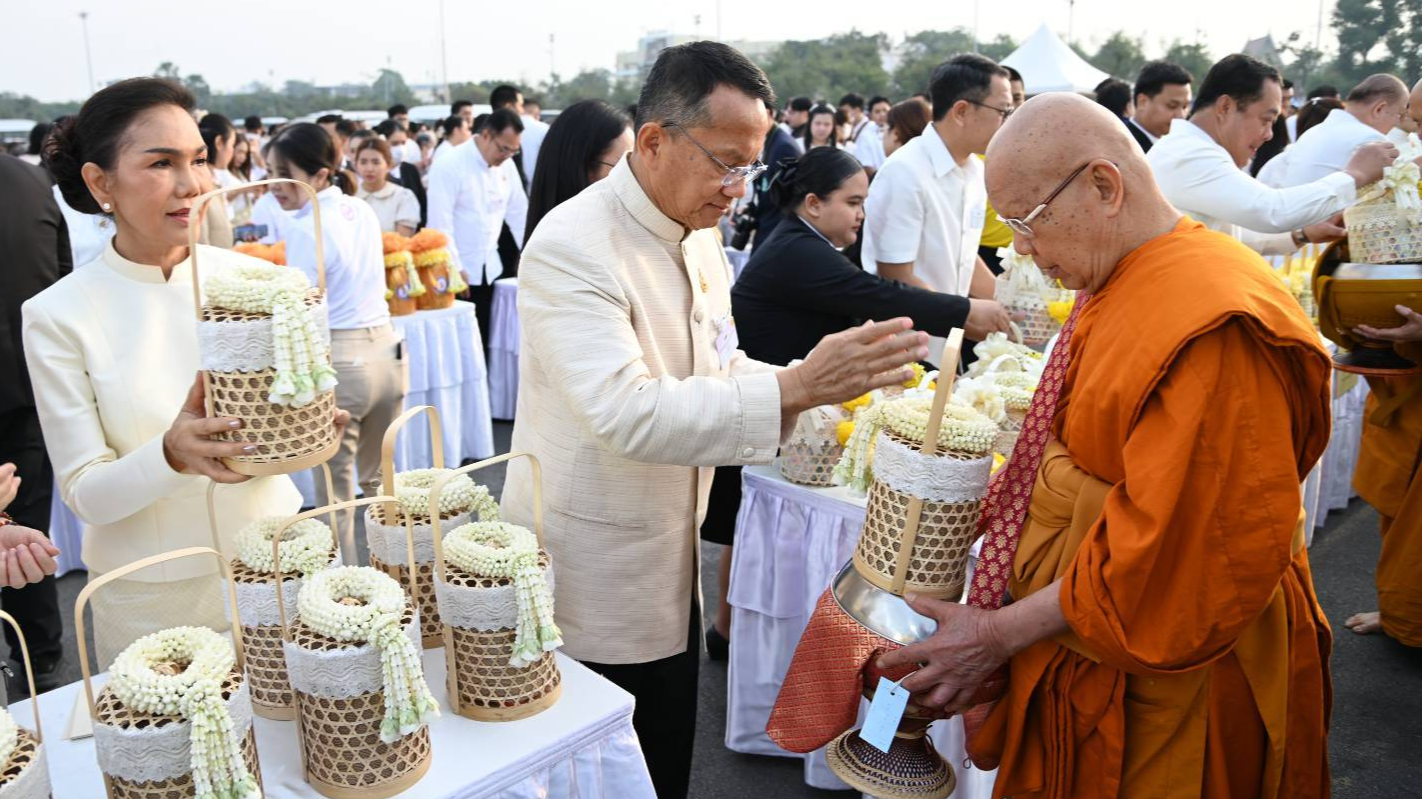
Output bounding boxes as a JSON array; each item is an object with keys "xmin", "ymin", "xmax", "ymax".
[{"xmin": 1146, "ymin": 54, "xmax": 1398, "ymax": 254}]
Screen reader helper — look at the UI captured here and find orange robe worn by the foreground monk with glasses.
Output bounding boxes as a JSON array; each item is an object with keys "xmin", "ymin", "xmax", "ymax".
[{"xmin": 973, "ymin": 219, "xmax": 1331, "ymax": 799}]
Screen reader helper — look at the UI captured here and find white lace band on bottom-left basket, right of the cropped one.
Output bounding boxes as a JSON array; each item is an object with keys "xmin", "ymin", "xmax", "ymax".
[{"xmin": 94, "ymin": 680, "xmax": 252, "ymax": 782}]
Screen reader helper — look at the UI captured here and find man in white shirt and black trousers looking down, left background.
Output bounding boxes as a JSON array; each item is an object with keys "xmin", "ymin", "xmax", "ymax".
[{"xmin": 428, "ymin": 108, "xmax": 529, "ymax": 343}]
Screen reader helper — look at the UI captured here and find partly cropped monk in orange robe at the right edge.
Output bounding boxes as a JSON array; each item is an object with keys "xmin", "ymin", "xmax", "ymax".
[{"xmin": 1344, "ymin": 308, "xmax": 1422, "ymax": 647}]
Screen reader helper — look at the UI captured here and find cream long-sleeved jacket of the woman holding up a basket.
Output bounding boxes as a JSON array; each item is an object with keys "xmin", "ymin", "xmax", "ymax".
[{"xmin": 23, "ymin": 242, "xmax": 301, "ymax": 581}]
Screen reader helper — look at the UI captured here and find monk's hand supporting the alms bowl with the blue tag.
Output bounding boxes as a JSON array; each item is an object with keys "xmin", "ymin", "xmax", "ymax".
[{"xmin": 879, "ymin": 594, "xmax": 1014, "ymax": 714}]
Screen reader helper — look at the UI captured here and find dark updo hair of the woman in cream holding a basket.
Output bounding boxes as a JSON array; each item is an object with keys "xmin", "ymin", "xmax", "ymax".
[{"xmin": 41, "ymin": 78, "xmax": 198, "ymax": 213}]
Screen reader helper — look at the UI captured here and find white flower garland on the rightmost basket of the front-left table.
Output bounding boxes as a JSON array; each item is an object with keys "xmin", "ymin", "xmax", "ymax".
[{"xmin": 444, "ymin": 522, "xmax": 563, "ymax": 668}]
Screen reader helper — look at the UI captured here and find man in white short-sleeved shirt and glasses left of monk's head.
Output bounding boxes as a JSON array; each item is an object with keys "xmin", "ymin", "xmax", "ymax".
[{"xmin": 862, "ymin": 54, "xmax": 1012, "ymax": 363}]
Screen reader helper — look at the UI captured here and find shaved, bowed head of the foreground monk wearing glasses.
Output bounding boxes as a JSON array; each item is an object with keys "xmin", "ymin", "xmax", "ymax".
[{"xmin": 987, "ymin": 92, "xmax": 1180, "ymax": 290}]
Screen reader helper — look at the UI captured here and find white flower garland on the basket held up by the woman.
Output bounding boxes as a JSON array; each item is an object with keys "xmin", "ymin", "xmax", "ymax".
[{"xmin": 205, "ymin": 263, "xmax": 336, "ymax": 408}]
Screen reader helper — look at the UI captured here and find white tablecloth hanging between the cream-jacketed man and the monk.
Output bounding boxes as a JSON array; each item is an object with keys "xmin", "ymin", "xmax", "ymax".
[{"xmin": 725, "ymin": 463, "xmax": 994, "ymax": 799}]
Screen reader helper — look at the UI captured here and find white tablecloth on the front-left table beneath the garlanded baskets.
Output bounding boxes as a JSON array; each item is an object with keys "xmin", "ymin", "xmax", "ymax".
[{"xmin": 10, "ymin": 648, "xmax": 656, "ymax": 799}]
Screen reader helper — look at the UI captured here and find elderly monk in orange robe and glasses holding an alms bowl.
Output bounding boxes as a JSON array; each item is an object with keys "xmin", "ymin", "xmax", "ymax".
[{"xmin": 879, "ymin": 94, "xmax": 1332, "ymax": 799}]
